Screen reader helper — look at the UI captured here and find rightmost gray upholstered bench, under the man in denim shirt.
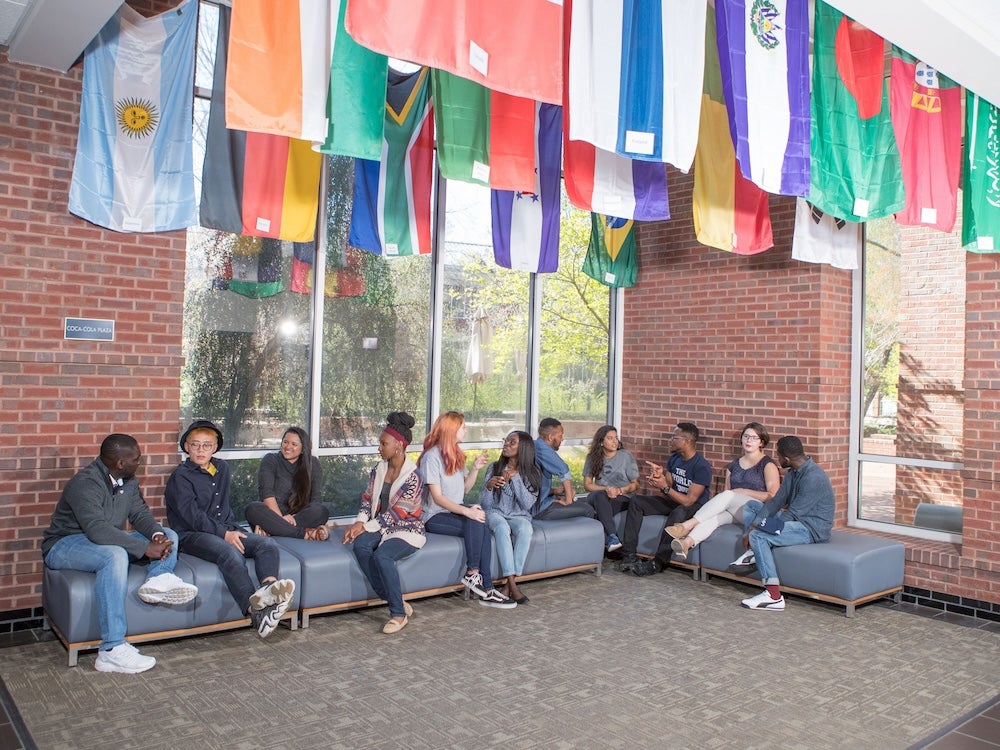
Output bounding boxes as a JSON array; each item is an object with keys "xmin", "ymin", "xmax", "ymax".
[{"xmin": 698, "ymin": 524, "xmax": 906, "ymax": 617}]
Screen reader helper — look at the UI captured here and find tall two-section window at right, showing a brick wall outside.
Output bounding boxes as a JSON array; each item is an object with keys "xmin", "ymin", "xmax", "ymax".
[{"xmin": 851, "ymin": 218, "xmax": 965, "ymax": 538}]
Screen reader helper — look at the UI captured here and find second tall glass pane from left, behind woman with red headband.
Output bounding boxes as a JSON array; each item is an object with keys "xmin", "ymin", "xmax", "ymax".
[{"xmin": 318, "ymin": 157, "xmax": 431, "ymax": 447}]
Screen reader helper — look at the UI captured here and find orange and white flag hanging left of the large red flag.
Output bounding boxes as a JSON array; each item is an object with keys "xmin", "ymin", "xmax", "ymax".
[{"xmin": 226, "ymin": 0, "xmax": 337, "ymax": 143}]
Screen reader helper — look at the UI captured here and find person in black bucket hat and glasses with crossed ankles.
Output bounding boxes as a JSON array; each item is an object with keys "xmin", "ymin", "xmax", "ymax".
[{"xmin": 164, "ymin": 419, "xmax": 295, "ymax": 638}]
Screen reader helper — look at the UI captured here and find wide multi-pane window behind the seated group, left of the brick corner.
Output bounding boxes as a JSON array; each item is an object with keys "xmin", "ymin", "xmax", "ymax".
[{"xmin": 178, "ymin": 2, "xmax": 612, "ymax": 517}]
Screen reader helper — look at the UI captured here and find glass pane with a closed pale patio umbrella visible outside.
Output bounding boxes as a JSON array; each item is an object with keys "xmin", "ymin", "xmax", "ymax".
[{"xmin": 441, "ymin": 181, "xmax": 531, "ymax": 442}]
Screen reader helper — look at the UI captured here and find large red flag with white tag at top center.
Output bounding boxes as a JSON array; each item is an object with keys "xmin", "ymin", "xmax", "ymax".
[{"xmin": 345, "ymin": 0, "xmax": 563, "ymax": 104}]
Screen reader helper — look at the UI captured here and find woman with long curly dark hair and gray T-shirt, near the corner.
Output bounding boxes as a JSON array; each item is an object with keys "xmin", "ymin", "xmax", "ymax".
[{"xmin": 583, "ymin": 424, "xmax": 639, "ymax": 552}]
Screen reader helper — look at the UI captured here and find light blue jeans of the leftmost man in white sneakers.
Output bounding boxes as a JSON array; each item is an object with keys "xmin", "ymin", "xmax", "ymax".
[{"xmin": 45, "ymin": 529, "xmax": 177, "ymax": 649}]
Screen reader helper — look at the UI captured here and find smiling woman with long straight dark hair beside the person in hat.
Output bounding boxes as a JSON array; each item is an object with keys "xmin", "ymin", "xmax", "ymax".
[{"xmin": 246, "ymin": 427, "xmax": 330, "ymax": 541}]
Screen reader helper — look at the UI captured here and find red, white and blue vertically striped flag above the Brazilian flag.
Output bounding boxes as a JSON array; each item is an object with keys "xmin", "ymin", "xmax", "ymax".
[{"xmin": 563, "ymin": 0, "xmax": 670, "ymax": 221}]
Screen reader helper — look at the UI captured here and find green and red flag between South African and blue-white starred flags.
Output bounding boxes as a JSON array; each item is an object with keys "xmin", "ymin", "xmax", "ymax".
[{"xmin": 431, "ymin": 70, "xmax": 535, "ymax": 191}]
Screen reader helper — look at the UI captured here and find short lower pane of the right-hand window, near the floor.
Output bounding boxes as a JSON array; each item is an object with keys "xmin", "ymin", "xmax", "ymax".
[{"xmin": 858, "ymin": 462, "xmax": 962, "ymax": 533}]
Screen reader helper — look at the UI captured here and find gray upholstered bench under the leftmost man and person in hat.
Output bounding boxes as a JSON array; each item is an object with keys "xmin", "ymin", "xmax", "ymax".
[{"xmin": 42, "ymin": 552, "xmax": 301, "ymax": 667}]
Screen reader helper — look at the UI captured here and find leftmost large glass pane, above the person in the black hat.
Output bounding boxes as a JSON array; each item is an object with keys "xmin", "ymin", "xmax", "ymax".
[{"xmin": 179, "ymin": 232, "xmax": 311, "ymax": 450}]
